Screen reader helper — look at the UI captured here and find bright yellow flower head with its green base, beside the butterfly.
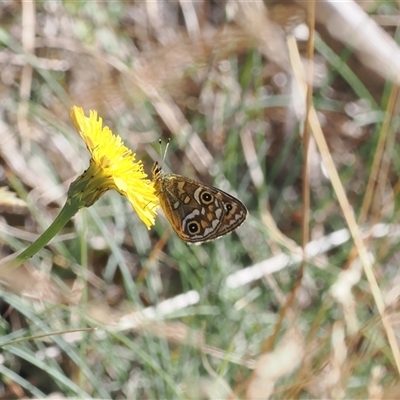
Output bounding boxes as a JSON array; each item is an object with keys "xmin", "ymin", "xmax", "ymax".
[{"xmin": 69, "ymin": 107, "xmax": 158, "ymax": 228}]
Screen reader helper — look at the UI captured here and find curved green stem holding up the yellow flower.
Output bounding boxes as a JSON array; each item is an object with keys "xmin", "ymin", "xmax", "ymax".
[{"xmin": 0, "ymin": 198, "xmax": 82, "ymax": 272}]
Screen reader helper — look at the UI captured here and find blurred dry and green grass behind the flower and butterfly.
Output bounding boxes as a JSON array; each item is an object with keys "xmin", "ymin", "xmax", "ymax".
[{"xmin": 0, "ymin": 0, "xmax": 400, "ymax": 399}]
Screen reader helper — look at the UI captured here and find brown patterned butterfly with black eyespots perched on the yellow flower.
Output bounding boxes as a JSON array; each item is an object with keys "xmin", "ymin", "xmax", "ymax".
[{"xmin": 152, "ymin": 162, "xmax": 247, "ymax": 244}]
